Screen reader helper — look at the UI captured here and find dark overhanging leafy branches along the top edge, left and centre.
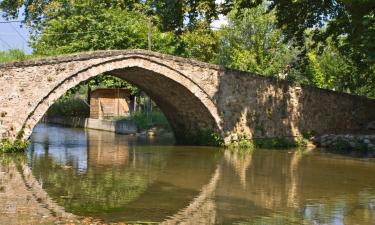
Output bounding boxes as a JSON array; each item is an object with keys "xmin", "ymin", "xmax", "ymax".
[{"xmin": 0, "ymin": 0, "xmax": 225, "ymax": 33}]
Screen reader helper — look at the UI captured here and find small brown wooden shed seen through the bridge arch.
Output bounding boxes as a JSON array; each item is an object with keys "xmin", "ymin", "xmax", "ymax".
[{"xmin": 90, "ymin": 88, "xmax": 134, "ymax": 119}]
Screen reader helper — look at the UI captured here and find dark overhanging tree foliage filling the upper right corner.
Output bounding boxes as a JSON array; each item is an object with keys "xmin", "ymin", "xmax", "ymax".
[{"xmin": 231, "ymin": 0, "xmax": 375, "ymax": 97}]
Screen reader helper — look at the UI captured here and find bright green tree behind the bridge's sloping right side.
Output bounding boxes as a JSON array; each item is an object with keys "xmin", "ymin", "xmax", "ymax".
[{"xmin": 217, "ymin": 5, "xmax": 297, "ymax": 76}]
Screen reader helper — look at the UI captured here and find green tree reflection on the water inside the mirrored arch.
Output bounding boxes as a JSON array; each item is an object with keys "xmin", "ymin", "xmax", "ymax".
[{"xmin": 33, "ymin": 157, "xmax": 148, "ymax": 214}]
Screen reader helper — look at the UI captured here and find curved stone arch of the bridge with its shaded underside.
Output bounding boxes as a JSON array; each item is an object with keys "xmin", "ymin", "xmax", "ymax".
[{"xmin": 22, "ymin": 55, "xmax": 222, "ymax": 142}]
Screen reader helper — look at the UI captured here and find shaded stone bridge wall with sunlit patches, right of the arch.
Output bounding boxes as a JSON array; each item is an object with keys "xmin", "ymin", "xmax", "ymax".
[{"xmin": 216, "ymin": 69, "xmax": 375, "ymax": 141}]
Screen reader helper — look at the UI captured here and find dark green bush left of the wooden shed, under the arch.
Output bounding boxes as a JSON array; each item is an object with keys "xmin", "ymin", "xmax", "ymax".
[{"xmin": 47, "ymin": 96, "xmax": 90, "ymax": 117}]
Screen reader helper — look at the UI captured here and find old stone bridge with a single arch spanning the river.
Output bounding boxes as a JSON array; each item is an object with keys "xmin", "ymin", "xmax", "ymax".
[{"xmin": 0, "ymin": 50, "xmax": 375, "ymax": 143}]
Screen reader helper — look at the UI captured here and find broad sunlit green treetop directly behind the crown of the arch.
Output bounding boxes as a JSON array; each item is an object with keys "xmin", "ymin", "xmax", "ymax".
[{"xmin": 32, "ymin": 6, "xmax": 173, "ymax": 55}]
